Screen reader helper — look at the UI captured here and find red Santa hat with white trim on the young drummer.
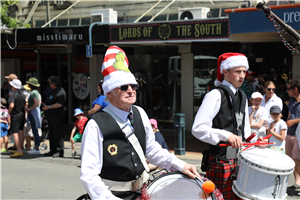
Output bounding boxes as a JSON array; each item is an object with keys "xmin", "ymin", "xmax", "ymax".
[{"xmin": 215, "ymin": 52, "xmax": 249, "ymax": 86}]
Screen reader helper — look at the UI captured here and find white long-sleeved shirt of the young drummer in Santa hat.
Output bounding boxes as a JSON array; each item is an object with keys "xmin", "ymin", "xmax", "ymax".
[{"xmin": 192, "ymin": 80, "xmax": 254, "ymax": 145}]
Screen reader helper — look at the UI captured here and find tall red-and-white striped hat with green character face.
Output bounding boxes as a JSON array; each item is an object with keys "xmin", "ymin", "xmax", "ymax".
[{"xmin": 102, "ymin": 46, "xmax": 137, "ymax": 94}]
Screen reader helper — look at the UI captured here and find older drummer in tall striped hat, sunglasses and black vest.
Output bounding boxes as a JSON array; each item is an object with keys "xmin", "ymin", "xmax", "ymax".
[{"xmin": 80, "ymin": 46, "xmax": 199, "ymax": 199}]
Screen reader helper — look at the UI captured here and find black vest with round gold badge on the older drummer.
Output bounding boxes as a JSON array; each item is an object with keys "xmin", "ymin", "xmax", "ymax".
[{"xmin": 92, "ymin": 106, "xmax": 146, "ymax": 181}]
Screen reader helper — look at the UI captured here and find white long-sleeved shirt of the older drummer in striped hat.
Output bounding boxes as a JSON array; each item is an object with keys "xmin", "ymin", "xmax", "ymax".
[{"xmin": 80, "ymin": 104, "xmax": 186, "ymax": 200}]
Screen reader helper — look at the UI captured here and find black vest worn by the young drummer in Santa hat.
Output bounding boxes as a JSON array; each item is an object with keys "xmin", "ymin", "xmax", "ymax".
[{"xmin": 210, "ymin": 86, "xmax": 246, "ymax": 161}]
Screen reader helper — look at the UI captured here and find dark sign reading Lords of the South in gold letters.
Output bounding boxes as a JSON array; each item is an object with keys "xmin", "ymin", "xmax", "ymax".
[{"xmin": 110, "ymin": 19, "xmax": 229, "ymax": 43}]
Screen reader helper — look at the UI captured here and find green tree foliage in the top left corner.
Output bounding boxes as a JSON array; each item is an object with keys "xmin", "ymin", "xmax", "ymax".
[{"xmin": 0, "ymin": 0, "xmax": 30, "ymax": 28}]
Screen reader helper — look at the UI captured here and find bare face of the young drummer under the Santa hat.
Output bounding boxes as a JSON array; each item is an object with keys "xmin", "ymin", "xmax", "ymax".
[{"xmin": 223, "ymin": 67, "xmax": 247, "ymax": 88}]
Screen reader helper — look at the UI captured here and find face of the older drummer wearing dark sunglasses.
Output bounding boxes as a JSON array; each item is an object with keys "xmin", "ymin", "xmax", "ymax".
[{"xmin": 107, "ymin": 84, "xmax": 136, "ymax": 111}]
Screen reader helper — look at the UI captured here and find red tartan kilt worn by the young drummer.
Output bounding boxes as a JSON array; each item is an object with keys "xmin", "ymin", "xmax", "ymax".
[{"xmin": 206, "ymin": 156, "xmax": 240, "ymax": 200}]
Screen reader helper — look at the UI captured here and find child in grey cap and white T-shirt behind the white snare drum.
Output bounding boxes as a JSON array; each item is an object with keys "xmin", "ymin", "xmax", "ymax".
[{"xmin": 268, "ymin": 105, "xmax": 287, "ymax": 153}]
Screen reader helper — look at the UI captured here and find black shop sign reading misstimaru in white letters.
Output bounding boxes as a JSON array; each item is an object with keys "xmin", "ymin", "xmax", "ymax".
[{"xmin": 18, "ymin": 25, "xmax": 108, "ymax": 45}]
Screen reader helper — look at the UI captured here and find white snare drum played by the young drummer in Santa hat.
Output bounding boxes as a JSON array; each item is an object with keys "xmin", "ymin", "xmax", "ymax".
[{"xmin": 232, "ymin": 147, "xmax": 295, "ymax": 200}]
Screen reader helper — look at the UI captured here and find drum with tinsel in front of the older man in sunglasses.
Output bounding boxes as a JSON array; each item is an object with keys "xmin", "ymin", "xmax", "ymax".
[{"xmin": 146, "ymin": 172, "xmax": 223, "ymax": 200}]
